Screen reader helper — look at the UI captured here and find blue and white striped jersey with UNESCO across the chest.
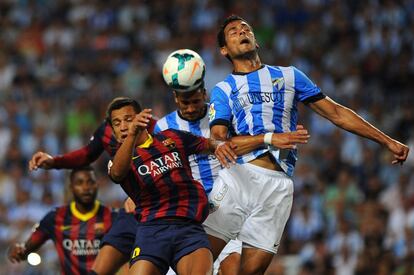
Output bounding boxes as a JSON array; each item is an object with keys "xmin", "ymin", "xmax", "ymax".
[{"xmin": 209, "ymin": 65, "xmax": 324, "ymax": 176}]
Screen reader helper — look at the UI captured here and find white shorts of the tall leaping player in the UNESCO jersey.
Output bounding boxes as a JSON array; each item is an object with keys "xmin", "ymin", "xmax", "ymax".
[{"xmin": 204, "ymin": 163, "xmax": 293, "ymax": 253}]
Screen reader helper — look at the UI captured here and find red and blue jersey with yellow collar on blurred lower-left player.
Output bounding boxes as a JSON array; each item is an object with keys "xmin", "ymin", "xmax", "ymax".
[{"xmin": 30, "ymin": 201, "xmax": 116, "ymax": 275}]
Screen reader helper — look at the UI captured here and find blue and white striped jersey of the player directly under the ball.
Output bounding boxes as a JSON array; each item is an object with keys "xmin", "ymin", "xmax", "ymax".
[{"xmin": 154, "ymin": 105, "xmax": 221, "ymax": 194}]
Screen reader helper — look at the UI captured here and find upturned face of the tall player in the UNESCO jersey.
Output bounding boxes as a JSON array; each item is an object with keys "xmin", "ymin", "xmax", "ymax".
[{"xmin": 220, "ymin": 20, "xmax": 258, "ymax": 59}]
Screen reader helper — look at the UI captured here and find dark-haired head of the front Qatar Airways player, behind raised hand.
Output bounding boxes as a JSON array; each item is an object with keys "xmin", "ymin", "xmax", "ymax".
[{"xmin": 106, "ymin": 97, "xmax": 141, "ymax": 142}]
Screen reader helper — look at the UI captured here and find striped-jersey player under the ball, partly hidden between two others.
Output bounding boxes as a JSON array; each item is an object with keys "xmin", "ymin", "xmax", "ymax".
[{"xmin": 154, "ymin": 50, "xmax": 309, "ymax": 275}]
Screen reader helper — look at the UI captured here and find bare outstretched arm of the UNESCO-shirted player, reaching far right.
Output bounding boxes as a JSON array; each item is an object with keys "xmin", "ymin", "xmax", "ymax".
[{"xmin": 308, "ymin": 97, "xmax": 409, "ymax": 164}]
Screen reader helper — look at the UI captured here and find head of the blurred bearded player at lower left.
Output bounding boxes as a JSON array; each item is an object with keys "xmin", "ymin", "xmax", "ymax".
[{"xmin": 69, "ymin": 166, "xmax": 98, "ymax": 205}]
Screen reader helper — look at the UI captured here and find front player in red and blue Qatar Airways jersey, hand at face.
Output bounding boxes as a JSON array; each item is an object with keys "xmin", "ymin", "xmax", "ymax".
[{"xmin": 108, "ymin": 99, "xmax": 236, "ymax": 274}]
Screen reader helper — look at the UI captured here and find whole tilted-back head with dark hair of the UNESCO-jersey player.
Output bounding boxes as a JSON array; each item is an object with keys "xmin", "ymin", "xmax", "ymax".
[{"xmin": 217, "ymin": 15, "xmax": 259, "ymax": 62}]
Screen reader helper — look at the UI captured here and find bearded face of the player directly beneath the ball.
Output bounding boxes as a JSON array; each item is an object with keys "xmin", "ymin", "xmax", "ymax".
[{"xmin": 175, "ymin": 88, "xmax": 207, "ymax": 121}]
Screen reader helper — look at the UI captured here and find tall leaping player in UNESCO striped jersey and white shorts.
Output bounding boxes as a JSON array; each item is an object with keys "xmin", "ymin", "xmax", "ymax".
[{"xmin": 204, "ymin": 16, "xmax": 408, "ymax": 274}]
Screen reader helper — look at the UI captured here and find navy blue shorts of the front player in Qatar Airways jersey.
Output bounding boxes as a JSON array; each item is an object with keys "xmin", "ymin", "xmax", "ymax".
[{"xmin": 130, "ymin": 219, "xmax": 211, "ymax": 274}]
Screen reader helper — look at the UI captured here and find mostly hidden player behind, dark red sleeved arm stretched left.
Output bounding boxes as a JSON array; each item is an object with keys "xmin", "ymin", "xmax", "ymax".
[{"xmin": 29, "ymin": 97, "xmax": 155, "ymax": 274}]
